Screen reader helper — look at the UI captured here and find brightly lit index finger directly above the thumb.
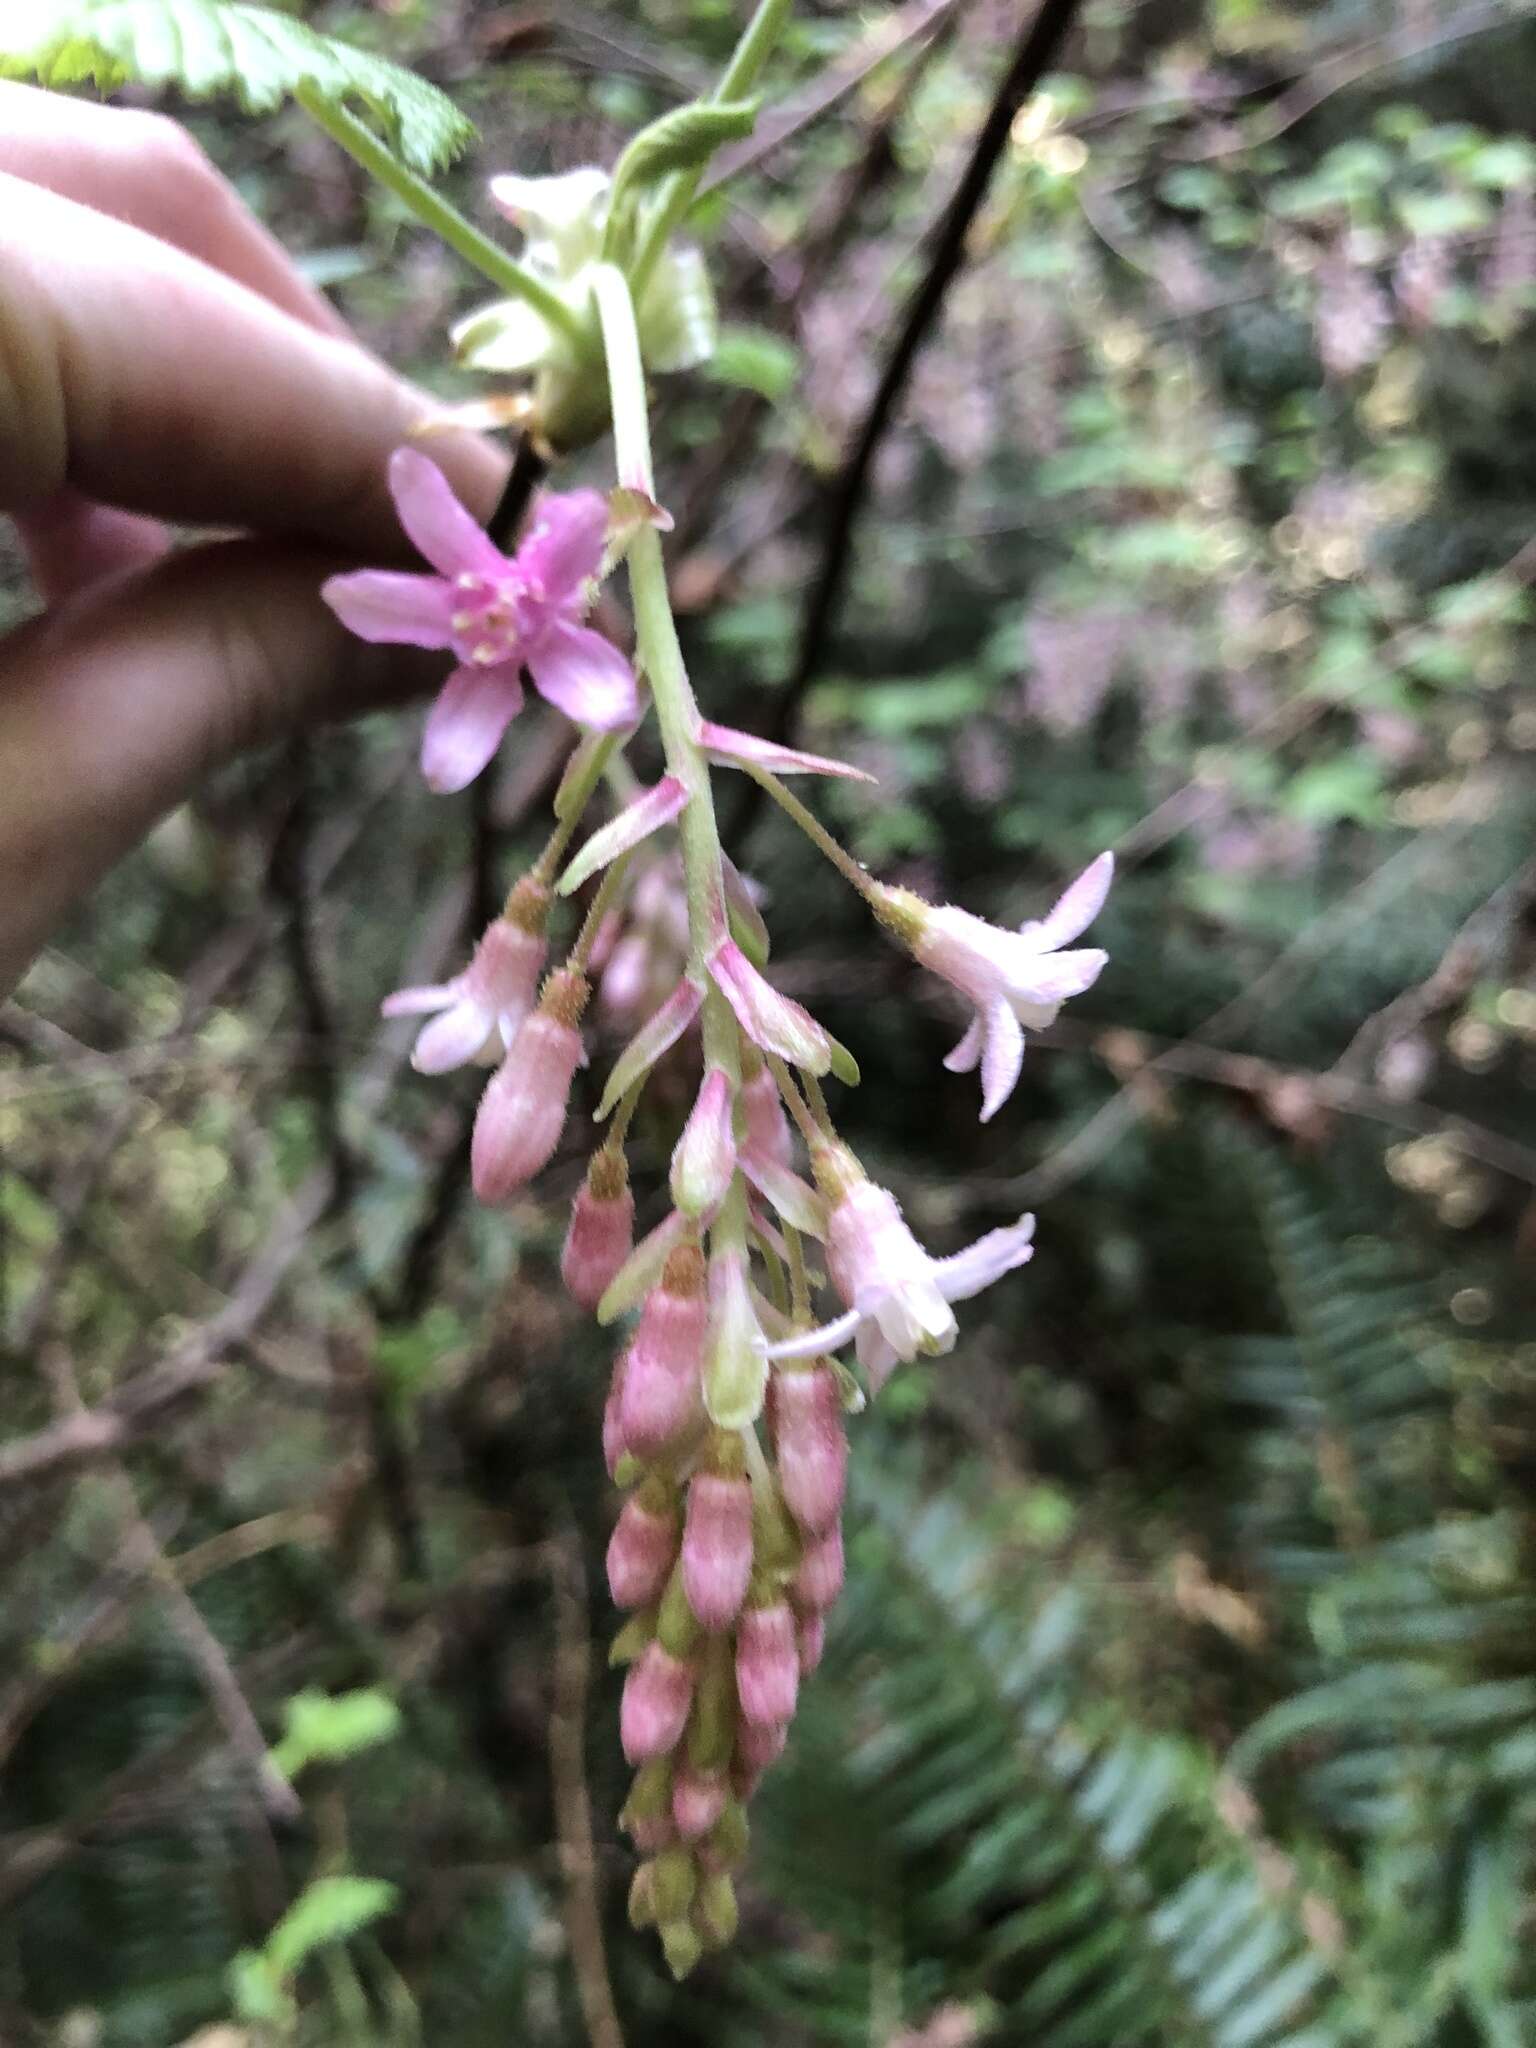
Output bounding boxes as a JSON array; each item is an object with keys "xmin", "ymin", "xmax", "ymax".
[{"xmin": 0, "ymin": 174, "xmax": 504, "ymax": 555}]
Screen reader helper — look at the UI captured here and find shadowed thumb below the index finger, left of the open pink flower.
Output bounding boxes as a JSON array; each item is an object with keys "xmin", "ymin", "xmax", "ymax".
[{"xmin": 0, "ymin": 541, "xmax": 442, "ymax": 995}]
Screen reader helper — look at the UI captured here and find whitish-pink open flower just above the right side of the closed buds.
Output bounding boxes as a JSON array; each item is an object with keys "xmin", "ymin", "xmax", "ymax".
[{"xmin": 766, "ymin": 1174, "xmax": 1034, "ymax": 1391}]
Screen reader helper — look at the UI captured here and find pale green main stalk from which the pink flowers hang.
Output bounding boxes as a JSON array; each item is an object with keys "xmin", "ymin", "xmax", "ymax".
[{"xmin": 592, "ymin": 264, "xmax": 741, "ymax": 1081}]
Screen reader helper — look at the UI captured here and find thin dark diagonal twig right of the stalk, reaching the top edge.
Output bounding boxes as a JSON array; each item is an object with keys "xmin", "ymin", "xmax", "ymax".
[{"xmin": 733, "ymin": 0, "xmax": 1077, "ymax": 836}]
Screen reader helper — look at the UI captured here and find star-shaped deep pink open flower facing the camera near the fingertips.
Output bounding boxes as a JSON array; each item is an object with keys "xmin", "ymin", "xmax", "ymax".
[{"xmin": 322, "ymin": 449, "xmax": 639, "ymax": 793}]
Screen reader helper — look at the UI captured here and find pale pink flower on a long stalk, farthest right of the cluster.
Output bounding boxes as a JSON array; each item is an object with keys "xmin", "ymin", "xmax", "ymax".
[{"xmin": 881, "ymin": 854, "xmax": 1114, "ymax": 1124}]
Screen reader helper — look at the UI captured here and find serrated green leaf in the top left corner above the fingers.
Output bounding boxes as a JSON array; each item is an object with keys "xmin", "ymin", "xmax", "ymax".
[{"xmin": 0, "ymin": 0, "xmax": 475, "ymax": 172}]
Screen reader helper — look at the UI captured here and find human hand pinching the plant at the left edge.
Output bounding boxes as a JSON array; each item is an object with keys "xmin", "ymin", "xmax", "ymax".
[{"xmin": 0, "ymin": 84, "xmax": 502, "ymax": 995}]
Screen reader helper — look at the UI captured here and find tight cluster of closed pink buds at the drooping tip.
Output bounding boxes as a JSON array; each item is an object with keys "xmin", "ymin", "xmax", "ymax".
[{"xmin": 608, "ymin": 1277, "xmax": 848, "ymax": 1972}]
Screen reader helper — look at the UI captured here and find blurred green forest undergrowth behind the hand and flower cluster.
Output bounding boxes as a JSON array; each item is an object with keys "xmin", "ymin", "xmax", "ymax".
[{"xmin": 0, "ymin": 0, "xmax": 1536, "ymax": 2048}]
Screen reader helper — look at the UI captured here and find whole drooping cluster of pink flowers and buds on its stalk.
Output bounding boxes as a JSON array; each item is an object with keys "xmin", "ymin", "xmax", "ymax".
[{"xmin": 326, "ymin": 155, "xmax": 1112, "ymax": 1974}]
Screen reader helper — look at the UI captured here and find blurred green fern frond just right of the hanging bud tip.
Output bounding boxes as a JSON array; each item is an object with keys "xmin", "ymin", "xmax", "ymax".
[{"xmin": 733, "ymin": 1470, "xmax": 1343, "ymax": 2048}]
